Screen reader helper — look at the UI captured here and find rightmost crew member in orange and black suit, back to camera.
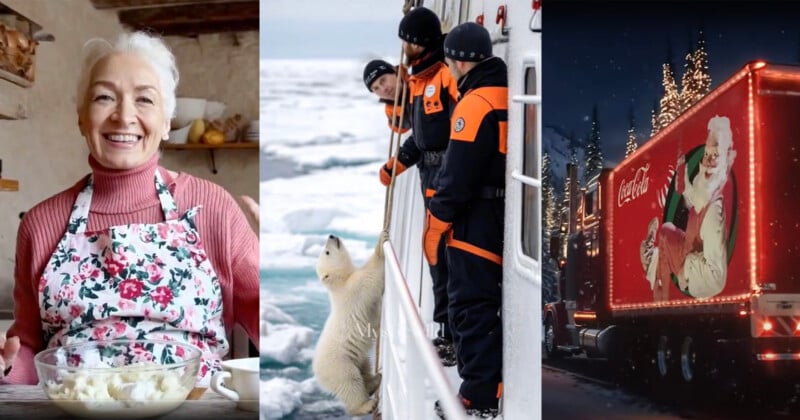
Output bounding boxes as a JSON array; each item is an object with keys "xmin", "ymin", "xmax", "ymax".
[{"xmin": 423, "ymin": 22, "xmax": 508, "ymax": 418}]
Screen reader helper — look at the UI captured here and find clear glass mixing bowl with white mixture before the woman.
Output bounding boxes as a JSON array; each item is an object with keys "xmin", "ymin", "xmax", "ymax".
[{"xmin": 34, "ymin": 340, "xmax": 201, "ymax": 419}]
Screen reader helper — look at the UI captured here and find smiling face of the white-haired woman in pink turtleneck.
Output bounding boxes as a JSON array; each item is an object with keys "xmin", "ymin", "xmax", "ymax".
[{"xmin": 78, "ymin": 53, "xmax": 169, "ymax": 169}]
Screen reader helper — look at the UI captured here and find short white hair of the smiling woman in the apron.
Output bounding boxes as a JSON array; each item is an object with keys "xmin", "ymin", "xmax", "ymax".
[{"xmin": 76, "ymin": 32, "xmax": 179, "ymax": 120}]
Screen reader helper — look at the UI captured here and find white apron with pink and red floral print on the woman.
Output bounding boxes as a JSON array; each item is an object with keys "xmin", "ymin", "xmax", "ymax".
[{"xmin": 39, "ymin": 171, "xmax": 229, "ymax": 387}]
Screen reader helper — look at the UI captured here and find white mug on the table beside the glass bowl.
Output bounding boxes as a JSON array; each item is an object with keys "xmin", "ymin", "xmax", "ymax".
[{"xmin": 211, "ymin": 357, "xmax": 261, "ymax": 411}]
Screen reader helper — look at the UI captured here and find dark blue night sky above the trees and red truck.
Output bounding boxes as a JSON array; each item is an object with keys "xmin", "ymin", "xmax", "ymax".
[{"xmin": 542, "ymin": 0, "xmax": 800, "ymax": 166}]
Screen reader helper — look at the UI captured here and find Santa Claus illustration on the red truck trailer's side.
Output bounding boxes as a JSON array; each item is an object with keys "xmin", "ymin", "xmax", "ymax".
[{"xmin": 639, "ymin": 116, "xmax": 736, "ymax": 302}]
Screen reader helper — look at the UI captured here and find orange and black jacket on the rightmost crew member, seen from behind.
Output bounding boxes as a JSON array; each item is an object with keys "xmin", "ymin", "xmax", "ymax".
[{"xmin": 430, "ymin": 57, "xmax": 508, "ymax": 255}]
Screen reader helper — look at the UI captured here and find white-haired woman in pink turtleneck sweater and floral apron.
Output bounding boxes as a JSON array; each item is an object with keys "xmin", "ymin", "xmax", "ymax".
[{"xmin": 0, "ymin": 33, "xmax": 259, "ymax": 387}]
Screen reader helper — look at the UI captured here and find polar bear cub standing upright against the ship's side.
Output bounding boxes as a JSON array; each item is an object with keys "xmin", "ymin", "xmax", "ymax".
[{"xmin": 313, "ymin": 232, "xmax": 388, "ymax": 416}]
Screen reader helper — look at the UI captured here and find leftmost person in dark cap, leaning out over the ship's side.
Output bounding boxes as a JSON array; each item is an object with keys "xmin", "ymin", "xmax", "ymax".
[{"xmin": 364, "ymin": 60, "xmax": 411, "ymax": 134}]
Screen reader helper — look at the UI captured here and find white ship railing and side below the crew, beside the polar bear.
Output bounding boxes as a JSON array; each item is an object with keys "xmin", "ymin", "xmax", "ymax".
[{"xmin": 377, "ymin": 167, "xmax": 467, "ymax": 420}]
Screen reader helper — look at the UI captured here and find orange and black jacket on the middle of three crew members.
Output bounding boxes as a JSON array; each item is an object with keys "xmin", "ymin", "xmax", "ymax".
[{"xmin": 389, "ymin": 46, "xmax": 458, "ymax": 166}]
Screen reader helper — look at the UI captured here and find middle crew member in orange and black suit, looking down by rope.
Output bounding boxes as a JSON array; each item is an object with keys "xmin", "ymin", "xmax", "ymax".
[{"xmin": 379, "ymin": 7, "xmax": 458, "ymax": 366}]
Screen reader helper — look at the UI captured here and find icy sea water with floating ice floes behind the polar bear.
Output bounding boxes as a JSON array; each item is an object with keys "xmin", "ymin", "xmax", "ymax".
[{"xmin": 260, "ymin": 58, "xmax": 389, "ymax": 420}]
